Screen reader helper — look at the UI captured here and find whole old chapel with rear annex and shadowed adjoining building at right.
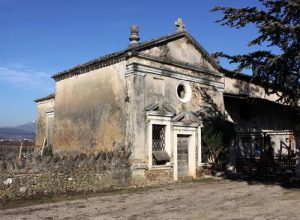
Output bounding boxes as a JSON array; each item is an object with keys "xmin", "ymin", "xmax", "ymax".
[{"xmin": 35, "ymin": 19, "xmax": 300, "ymax": 181}]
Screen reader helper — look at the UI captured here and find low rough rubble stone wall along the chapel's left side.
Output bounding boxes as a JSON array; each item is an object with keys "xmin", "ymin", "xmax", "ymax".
[{"xmin": 0, "ymin": 145, "xmax": 131, "ymax": 202}]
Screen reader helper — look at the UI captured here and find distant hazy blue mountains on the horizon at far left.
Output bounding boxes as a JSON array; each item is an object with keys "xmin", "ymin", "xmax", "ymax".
[{"xmin": 0, "ymin": 122, "xmax": 35, "ymax": 140}]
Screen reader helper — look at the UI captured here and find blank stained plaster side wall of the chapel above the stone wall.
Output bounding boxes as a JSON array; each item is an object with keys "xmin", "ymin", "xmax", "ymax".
[{"xmin": 54, "ymin": 62, "xmax": 126, "ymax": 153}]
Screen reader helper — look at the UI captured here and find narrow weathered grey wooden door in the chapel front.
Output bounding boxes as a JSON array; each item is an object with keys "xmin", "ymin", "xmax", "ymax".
[{"xmin": 177, "ymin": 135, "xmax": 189, "ymax": 178}]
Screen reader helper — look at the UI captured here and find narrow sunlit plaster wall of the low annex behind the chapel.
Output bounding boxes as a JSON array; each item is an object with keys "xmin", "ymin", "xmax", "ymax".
[{"xmin": 35, "ymin": 98, "xmax": 55, "ymax": 151}]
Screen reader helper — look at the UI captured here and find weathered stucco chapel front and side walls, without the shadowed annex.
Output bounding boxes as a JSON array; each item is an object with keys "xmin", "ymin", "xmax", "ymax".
[{"xmin": 37, "ymin": 21, "xmax": 224, "ymax": 180}]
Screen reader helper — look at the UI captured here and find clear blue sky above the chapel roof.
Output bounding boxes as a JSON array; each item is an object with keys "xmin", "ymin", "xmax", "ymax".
[{"xmin": 0, "ymin": 0, "xmax": 259, "ymax": 126}]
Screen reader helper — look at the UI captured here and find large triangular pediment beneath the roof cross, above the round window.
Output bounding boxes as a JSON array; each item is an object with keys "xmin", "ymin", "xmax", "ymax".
[{"xmin": 135, "ymin": 32, "xmax": 219, "ymax": 72}]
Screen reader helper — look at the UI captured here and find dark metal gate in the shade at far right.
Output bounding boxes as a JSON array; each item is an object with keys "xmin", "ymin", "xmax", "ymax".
[{"xmin": 236, "ymin": 131, "xmax": 296, "ymax": 179}]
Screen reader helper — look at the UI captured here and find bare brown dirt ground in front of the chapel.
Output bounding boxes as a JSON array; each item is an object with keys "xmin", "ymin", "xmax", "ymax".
[{"xmin": 0, "ymin": 180, "xmax": 300, "ymax": 220}]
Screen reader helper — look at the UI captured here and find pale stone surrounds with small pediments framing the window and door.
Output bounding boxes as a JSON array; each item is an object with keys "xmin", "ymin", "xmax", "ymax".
[{"xmin": 146, "ymin": 104, "xmax": 202, "ymax": 181}]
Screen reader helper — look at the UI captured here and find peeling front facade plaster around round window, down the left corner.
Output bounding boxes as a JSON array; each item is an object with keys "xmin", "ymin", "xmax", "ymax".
[{"xmin": 126, "ymin": 55, "xmax": 224, "ymax": 164}]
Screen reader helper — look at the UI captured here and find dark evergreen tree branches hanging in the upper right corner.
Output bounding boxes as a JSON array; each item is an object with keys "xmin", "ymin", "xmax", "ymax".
[{"xmin": 212, "ymin": 0, "xmax": 300, "ymax": 106}]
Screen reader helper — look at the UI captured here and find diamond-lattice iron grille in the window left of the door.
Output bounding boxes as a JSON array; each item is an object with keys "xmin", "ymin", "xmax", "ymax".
[{"xmin": 152, "ymin": 125, "xmax": 166, "ymax": 151}]
